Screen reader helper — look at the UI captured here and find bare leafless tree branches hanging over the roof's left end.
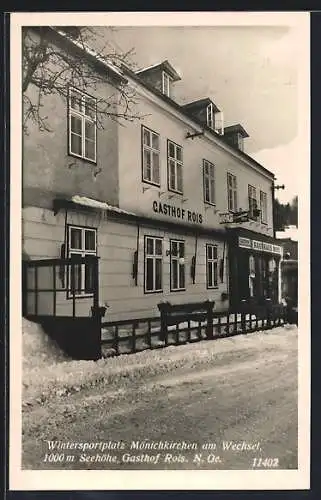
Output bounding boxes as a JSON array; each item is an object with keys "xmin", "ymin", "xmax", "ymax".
[{"xmin": 22, "ymin": 26, "xmax": 141, "ymax": 132}]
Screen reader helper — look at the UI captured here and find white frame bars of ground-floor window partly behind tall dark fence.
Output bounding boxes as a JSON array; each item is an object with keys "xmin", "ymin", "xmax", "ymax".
[{"xmin": 67, "ymin": 225, "xmax": 97, "ymax": 298}]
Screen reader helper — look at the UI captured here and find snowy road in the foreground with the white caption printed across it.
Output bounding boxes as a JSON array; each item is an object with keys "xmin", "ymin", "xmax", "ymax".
[{"xmin": 23, "ymin": 333, "xmax": 297, "ymax": 470}]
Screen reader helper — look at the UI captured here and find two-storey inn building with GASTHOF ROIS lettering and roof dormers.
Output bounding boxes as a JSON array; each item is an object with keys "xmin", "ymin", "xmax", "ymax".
[{"xmin": 23, "ymin": 29, "xmax": 282, "ymax": 320}]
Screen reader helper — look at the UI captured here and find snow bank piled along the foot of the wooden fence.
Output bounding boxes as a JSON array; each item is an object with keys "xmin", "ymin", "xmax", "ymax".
[{"xmin": 23, "ymin": 321, "xmax": 297, "ymax": 406}]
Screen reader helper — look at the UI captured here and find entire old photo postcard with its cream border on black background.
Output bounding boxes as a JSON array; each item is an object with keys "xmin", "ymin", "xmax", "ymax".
[{"xmin": 9, "ymin": 12, "xmax": 310, "ymax": 490}]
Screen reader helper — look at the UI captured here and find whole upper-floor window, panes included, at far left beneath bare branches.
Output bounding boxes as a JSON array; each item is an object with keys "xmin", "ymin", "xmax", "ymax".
[{"xmin": 68, "ymin": 88, "xmax": 97, "ymax": 162}]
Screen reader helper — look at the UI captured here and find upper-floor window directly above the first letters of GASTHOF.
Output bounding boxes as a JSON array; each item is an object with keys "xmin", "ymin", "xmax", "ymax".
[{"xmin": 142, "ymin": 127, "xmax": 160, "ymax": 186}]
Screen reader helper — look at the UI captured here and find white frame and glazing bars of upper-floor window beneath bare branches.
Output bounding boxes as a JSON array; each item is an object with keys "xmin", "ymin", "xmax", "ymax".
[{"xmin": 68, "ymin": 87, "xmax": 97, "ymax": 163}]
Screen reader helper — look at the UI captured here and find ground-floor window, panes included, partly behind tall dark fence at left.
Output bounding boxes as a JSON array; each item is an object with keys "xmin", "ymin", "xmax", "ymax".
[{"xmin": 68, "ymin": 226, "xmax": 97, "ymax": 297}]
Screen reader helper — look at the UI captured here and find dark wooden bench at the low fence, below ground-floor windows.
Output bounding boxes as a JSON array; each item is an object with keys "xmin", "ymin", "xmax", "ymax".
[{"xmin": 158, "ymin": 300, "xmax": 215, "ymax": 345}]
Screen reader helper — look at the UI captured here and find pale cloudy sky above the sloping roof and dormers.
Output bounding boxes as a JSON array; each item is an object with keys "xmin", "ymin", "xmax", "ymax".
[{"xmin": 98, "ymin": 26, "xmax": 302, "ymax": 202}]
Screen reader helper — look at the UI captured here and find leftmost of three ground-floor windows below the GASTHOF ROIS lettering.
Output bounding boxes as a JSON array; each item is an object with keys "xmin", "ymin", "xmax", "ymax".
[{"xmin": 145, "ymin": 236, "xmax": 163, "ymax": 293}]
